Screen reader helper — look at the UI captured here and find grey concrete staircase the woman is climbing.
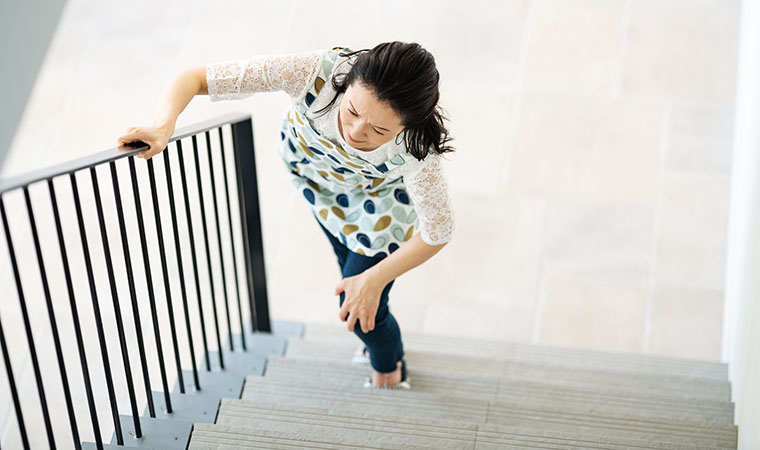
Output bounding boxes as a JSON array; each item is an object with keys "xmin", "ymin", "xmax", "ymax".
[{"xmin": 189, "ymin": 324, "xmax": 737, "ymax": 450}]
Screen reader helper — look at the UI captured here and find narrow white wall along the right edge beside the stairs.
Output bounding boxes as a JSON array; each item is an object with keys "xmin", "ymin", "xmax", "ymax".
[{"xmin": 723, "ymin": 0, "xmax": 760, "ymax": 449}]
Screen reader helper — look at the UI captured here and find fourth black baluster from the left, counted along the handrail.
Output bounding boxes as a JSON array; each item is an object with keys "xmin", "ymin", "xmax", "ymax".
[{"xmin": 69, "ymin": 172, "xmax": 124, "ymax": 445}]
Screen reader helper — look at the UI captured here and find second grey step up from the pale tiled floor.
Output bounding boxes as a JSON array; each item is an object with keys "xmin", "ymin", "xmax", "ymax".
[{"xmin": 285, "ymin": 339, "xmax": 731, "ymax": 402}]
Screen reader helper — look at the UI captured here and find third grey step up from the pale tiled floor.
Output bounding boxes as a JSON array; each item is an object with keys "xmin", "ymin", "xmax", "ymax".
[{"xmin": 265, "ymin": 357, "xmax": 734, "ymax": 423}]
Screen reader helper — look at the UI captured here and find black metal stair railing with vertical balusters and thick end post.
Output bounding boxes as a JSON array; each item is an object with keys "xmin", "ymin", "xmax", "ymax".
[{"xmin": 0, "ymin": 114, "xmax": 271, "ymax": 449}]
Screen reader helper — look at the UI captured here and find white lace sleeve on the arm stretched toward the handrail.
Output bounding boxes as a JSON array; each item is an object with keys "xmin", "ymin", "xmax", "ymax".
[{"xmin": 206, "ymin": 51, "xmax": 326, "ymax": 102}]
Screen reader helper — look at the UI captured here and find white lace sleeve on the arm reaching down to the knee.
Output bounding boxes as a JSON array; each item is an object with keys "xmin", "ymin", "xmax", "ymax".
[{"xmin": 404, "ymin": 155, "xmax": 455, "ymax": 245}]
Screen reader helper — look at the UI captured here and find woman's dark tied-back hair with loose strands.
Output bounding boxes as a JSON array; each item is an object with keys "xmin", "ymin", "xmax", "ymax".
[{"xmin": 317, "ymin": 41, "xmax": 454, "ymax": 161}]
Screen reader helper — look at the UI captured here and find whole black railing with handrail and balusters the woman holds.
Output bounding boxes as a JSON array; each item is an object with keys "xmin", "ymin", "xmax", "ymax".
[{"xmin": 0, "ymin": 114, "xmax": 271, "ymax": 450}]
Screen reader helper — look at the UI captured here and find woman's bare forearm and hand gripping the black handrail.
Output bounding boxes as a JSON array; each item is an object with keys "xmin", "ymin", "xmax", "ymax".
[{"xmin": 117, "ymin": 66, "xmax": 208, "ymax": 159}]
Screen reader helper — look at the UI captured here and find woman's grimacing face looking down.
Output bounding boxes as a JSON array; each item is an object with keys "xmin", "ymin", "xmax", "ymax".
[{"xmin": 338, "ymin": 82, "xmax": 404, "ymax": 150}]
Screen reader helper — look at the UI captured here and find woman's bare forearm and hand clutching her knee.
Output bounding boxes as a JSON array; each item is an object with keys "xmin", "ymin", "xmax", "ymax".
[{"xmin": 335, "ymin": 233, "xmax": 446, "ymax": 333}]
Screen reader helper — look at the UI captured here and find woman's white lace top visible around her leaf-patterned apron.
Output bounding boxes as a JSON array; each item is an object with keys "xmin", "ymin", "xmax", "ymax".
[{"xmin": 206, "ymin": 51, "xmax": 455, "ymax": 245}]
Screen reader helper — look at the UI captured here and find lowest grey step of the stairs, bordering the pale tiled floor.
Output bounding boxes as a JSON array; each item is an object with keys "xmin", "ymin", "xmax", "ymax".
[{"xmin": 304, "ymin": 323, "xmax": 728, "ymax": 381}]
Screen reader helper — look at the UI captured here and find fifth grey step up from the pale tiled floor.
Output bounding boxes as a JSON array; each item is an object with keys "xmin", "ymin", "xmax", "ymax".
[{"xmin": 211, "ymin": 399, "xmax": 725, "ymax": 450}]
